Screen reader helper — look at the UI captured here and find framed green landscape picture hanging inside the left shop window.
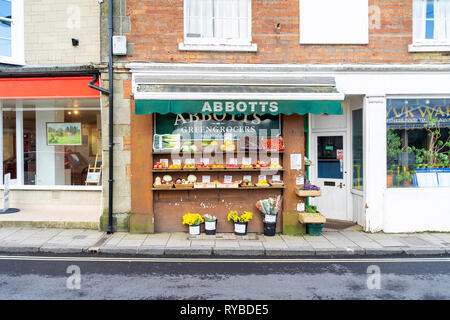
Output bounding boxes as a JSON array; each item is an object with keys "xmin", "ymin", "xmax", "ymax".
[{"xmin": 46, "ymin": 122, "xmax": 82, "ymax": 146}]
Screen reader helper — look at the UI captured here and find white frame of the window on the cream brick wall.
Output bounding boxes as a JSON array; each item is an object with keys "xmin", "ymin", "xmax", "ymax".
[{"xmin": 0, "ymin": 0, "xmax": 25, "ymax": 65}]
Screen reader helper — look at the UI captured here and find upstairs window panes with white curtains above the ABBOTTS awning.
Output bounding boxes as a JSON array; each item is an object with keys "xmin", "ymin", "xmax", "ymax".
[{"xmin": 184, "ymin": 0, "xmax": 251, "ymax": 45}]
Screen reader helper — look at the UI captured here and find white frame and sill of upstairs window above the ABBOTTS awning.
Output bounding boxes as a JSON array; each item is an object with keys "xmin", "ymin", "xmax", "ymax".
[{"xmin": 178, "ymin": 0, "xmax": 257, "ymax": 51}]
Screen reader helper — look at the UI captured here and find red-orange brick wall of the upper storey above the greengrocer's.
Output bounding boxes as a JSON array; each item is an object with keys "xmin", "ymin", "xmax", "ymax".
[{"xmin": 121, "ymin": 0, "xmax": 450, "ymax": 63}]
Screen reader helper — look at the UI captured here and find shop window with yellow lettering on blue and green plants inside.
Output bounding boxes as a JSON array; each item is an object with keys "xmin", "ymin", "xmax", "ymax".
[{"xmin": 386, "ymin": 99, "xmax": 450, "ymax": 188}]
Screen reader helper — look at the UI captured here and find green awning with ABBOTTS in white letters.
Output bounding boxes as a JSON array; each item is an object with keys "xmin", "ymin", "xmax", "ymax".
[{"xmin": 135, "ymin": 84, "xmax": 344, "ymax": 115}]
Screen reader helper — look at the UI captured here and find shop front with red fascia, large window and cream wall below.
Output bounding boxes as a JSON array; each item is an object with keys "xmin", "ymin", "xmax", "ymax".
[{"xmin": 0, "ymin": 74, "xmax": 102, "ymax": 228}]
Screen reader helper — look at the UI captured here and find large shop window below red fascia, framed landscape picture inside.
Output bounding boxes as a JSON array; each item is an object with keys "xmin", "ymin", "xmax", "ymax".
[{"xmin": 1, "ymin": 99, "xmax": 101, "ymax": 186}]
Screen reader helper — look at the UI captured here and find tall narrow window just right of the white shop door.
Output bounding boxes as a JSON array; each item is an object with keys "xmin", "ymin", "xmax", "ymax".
[{"xmin": 352, "ymin": 109, "xmax": 364, "ymax": 190}]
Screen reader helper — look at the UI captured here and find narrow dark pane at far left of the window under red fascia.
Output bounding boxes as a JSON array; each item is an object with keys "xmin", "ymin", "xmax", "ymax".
[{"xmin": 3, "ymin": 111, "xmax": 17, "ymax": 179}]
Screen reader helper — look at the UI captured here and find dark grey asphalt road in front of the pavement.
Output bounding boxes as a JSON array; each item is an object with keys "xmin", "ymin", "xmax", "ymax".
[{"xmin": 0, "ymin": 255, "xmax": 450, "ymax": 300}]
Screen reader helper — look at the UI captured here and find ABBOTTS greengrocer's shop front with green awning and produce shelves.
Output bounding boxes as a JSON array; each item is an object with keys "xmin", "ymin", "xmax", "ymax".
[{"xmin": 131, "ymin": 74, "xmax": 344, "ymax": 233}]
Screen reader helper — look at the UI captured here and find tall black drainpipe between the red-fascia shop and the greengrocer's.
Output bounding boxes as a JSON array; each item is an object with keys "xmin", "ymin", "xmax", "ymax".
[{"xmin": 88, "ymin": 0, "xmax": 114, "ymax": 234}]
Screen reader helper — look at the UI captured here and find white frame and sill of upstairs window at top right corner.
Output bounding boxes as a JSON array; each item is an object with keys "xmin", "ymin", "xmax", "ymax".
[{"xmin": 408, "ymin": 0, "xmax": 450, "ymax": 52}]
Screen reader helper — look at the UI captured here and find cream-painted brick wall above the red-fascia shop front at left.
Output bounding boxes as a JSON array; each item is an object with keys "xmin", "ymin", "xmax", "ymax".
[{"xmin": 24, "ymin": 0, "xmax": 100, "ymax": 64}]
